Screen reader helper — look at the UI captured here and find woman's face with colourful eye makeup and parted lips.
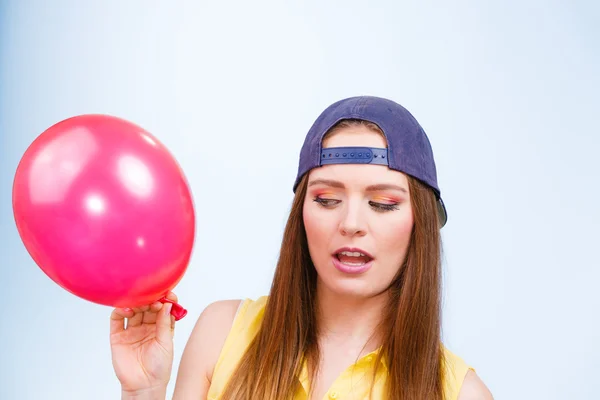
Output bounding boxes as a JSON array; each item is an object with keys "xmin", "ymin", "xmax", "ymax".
[{"xmin": 303, "ymin": 126, "xmax": 413, "ymax": 297}]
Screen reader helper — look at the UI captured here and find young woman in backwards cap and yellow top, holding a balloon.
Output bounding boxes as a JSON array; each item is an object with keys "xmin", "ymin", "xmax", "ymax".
[{"xmin": 111, "ymin": 97, "xmax": 492, "ymax": 400}]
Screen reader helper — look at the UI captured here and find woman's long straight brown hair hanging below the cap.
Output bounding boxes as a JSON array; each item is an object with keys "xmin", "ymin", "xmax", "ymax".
[{"xmin": 222, "ymin": 121, "xmax": 445, "ymax": 400}]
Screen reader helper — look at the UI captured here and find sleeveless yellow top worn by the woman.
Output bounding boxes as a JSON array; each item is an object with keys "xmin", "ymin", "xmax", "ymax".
[{"xmin": 208, "ymin": 296, "xmax": 474, "ymax": 400}]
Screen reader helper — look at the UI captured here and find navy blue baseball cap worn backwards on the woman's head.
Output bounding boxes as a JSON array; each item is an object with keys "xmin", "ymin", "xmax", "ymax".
[{"xmin": 293, "ymin": 96, "xmax": 448, "ymax": 227}]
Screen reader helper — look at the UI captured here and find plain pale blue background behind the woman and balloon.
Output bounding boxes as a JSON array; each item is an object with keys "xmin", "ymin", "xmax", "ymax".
[{"xmin": 0, "ymin": 0, "xmax": 600, "ymax": 400}]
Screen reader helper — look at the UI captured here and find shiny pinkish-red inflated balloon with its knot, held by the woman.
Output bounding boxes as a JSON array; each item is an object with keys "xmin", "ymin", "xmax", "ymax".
[{"xmin": 12, "ymin": 115, "xmax": 195, "ymax": 319}]
